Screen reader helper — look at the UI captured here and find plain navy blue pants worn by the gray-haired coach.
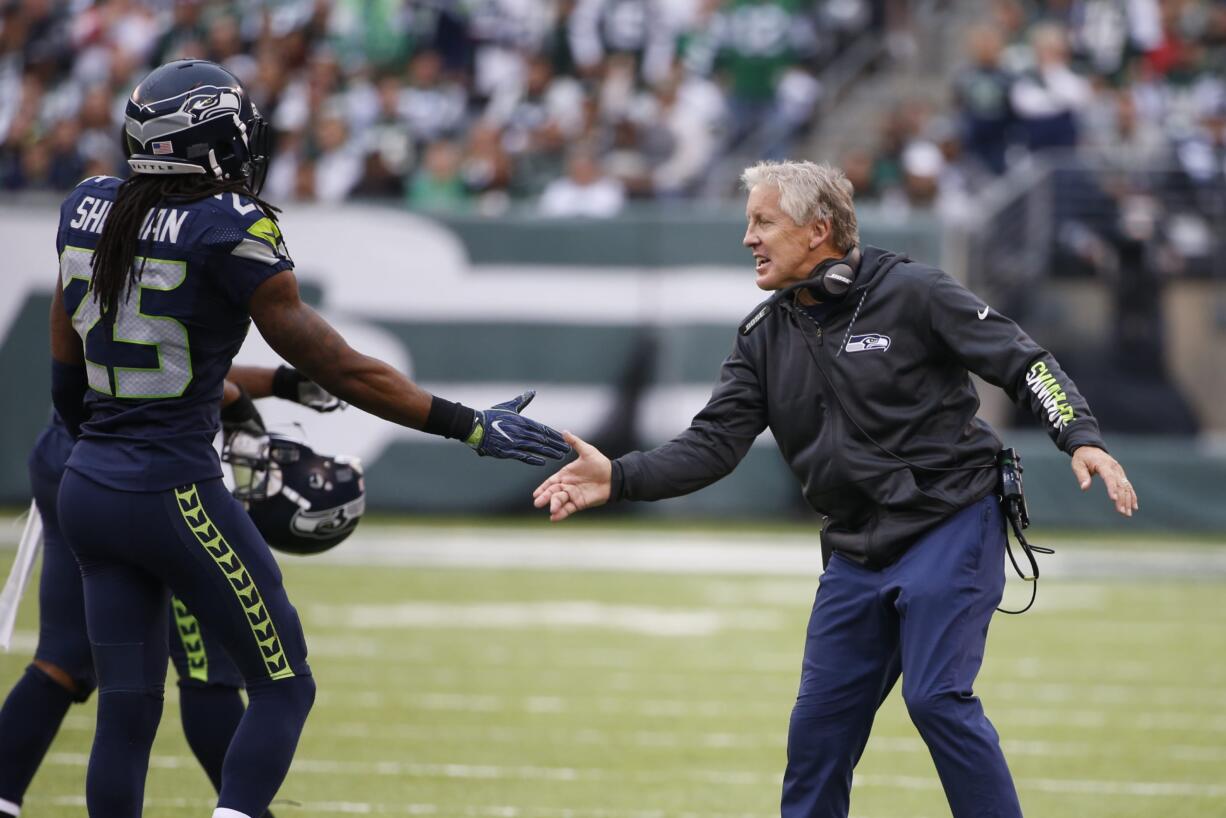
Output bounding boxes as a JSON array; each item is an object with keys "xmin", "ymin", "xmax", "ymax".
[{"xmin": 782, "ymin": 497, "xmax": 1021, "ymax": 818}]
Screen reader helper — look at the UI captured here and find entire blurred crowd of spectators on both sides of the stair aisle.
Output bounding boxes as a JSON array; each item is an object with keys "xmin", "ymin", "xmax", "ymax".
[{"xmin": 9, "ymin": 0, "xmax": 1226, "ymax": 220}]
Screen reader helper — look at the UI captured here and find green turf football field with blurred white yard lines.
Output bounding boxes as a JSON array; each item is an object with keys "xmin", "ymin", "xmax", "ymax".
[{"xmin": 0, "ymin": 526, "xmax": 1226, "ymax": 818}]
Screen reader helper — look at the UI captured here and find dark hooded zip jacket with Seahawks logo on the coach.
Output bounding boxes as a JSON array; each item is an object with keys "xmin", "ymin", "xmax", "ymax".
[{"xmin": 611, "ymin": 248, "xmax": 1105, "ymax": 568}]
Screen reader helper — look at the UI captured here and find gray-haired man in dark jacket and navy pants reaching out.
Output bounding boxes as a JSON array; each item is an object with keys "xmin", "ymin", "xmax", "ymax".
[{"xmin": 535, "ymin": 162, "xmax": 1138, "ymax": 818}]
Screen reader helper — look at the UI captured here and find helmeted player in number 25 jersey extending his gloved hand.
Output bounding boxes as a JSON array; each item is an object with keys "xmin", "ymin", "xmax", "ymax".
[{"xmin": 51, "ymin": 60, "xmax": 569, "ymax": 818}]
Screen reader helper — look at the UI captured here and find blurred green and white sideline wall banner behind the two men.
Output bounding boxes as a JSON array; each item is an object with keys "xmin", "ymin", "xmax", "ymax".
[{"xmin": 0, "ymin": 199, "xmax": 1226, "ymax": 530}]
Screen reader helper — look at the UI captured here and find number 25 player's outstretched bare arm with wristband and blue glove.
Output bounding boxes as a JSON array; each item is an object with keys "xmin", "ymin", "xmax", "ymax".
[{"xmin": 249, "ymin": 270, "xmax": 569, "ymax": 465}]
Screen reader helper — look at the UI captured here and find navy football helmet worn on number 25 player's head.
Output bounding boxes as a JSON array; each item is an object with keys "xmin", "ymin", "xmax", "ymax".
[{"xmin": 124, "ymin": 60, "xmax": 270, "ymax": 194}]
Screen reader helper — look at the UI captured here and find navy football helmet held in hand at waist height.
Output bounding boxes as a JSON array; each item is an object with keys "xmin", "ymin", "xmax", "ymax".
[{"xmin": 222, "ymin": 432, "xmax": 367, "ymax": 554}]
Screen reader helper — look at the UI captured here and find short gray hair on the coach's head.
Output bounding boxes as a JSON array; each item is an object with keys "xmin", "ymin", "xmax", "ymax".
[{"xmin": 741, "ymin": 162, "xmax": 859, "ymax": 253}]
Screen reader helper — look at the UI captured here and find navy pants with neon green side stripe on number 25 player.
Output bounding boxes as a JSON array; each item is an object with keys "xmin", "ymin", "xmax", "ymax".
[{"xmin": 59, "ymin": 470, "xmax": 315, "ymax": 818}]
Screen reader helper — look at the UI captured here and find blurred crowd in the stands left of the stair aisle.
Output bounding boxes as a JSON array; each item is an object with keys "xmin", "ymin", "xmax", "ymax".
[{"xmin": 0, "ymin": 0, "xmax": 897, "ymax": 216}]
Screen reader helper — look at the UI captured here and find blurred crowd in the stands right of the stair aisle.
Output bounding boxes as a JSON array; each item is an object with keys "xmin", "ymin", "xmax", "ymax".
[{"xmin": 840, "ymin": 0, "xmax": 1226, "ymax": 220}]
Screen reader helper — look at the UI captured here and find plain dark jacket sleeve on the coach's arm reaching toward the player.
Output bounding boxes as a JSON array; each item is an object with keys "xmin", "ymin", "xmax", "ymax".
[{"xmin": 609, "ymin": 337, "xmax": 766, "ymax": 500}]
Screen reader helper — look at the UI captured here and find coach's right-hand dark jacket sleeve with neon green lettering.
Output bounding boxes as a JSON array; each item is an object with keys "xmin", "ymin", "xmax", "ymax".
[{"xmin": 928, "ymin": 273, "xmax": 1106, "ymax": 454}]
